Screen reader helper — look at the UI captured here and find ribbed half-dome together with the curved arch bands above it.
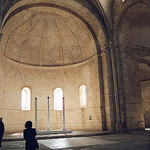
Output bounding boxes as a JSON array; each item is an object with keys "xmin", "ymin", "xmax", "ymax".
[{"xmin": 1, "ymin": 0, "xmax": 108, "ymax": 66}]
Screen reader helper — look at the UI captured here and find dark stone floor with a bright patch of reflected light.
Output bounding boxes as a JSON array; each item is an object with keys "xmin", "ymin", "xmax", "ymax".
[{"xmin": 0, "ymin": 131, "xmax": 150, "ymax": 150}]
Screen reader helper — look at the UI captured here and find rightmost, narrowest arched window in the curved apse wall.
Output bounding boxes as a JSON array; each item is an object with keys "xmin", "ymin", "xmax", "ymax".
[{"xmin": 79, "ymin": 85, "xmax": 87, "ymax": 108}]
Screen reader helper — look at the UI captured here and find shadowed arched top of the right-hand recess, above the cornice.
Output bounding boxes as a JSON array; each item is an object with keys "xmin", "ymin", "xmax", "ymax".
[{"xmin": 116, "ymin": 2, "xmax": 150, "ymax": 47}]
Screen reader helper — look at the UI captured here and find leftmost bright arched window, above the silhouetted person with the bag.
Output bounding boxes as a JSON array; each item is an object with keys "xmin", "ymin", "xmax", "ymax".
[{"xmin": 21, "ymin": 87, "xmax": 31, "ymax": 110}]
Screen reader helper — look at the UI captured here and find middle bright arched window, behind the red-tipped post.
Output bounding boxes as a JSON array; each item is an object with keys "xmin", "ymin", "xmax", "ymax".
[{"xmin": 54, "ymin": 88, "xmax": 63, "ymax": 110}]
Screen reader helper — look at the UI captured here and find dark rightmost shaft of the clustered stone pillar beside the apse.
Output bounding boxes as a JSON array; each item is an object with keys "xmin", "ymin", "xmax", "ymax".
[{"xmin": 111, "ymin": 45, "xmax": 126, "ymax": 132}]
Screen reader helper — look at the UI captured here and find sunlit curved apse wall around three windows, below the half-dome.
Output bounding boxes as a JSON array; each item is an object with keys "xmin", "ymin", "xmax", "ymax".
[{"xmin": 0, "ymin": 56, "xmax": 101, "ymax": 132}]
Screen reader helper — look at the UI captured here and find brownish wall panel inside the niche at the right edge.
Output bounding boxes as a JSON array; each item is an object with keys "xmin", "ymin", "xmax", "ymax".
[{"xmin": 141, "ymin": 81, "xmax": 150, "ymax": 128}]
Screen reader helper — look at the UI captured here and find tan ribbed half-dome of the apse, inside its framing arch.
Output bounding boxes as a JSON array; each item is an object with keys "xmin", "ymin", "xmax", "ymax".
[{"xmin": 2, "ymin": 7, "xmax": 97, "ymax": 66}]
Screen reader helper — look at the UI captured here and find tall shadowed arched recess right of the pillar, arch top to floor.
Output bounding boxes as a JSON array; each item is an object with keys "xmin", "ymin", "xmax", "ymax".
[{"xmin": 115, "ymin": 2, "xmax": 150, "ymax": 129}]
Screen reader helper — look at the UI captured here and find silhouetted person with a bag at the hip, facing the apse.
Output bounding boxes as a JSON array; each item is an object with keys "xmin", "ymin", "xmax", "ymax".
[{"xmin": 23, "ymin": 121, "xmax": 39, "ymax": 150}]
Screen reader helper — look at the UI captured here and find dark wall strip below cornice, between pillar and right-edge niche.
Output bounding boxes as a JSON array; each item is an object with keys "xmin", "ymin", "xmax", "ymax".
[{"xmin": 122, "ymin": 48, "xmax": 144, "ymax": 130}]
